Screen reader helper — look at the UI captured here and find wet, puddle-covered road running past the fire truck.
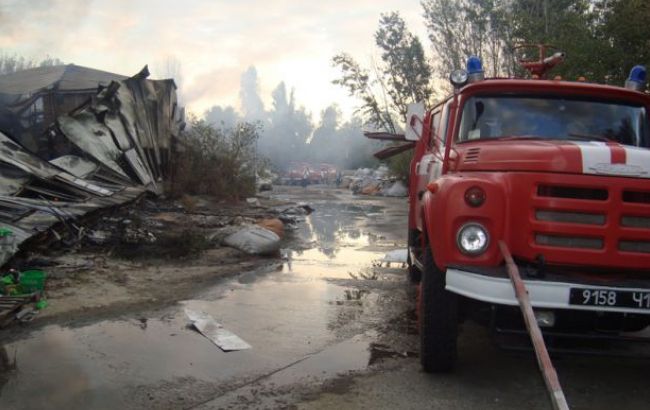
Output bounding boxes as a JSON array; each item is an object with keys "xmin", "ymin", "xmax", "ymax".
[{"xmin": 0, "ymin": 187, "xmax": 650, "ymax": 409}]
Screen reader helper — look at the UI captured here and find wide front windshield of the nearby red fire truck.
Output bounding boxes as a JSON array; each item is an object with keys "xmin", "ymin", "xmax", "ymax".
[{"xmin": 458, "ymin": 96, "xmax": 649, "ymax": 148}]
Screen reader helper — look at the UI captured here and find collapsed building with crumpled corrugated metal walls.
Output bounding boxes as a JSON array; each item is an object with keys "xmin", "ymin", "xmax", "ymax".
[{"xmin": 0, "ymin": 64, "xmax": 184, "ymax": 265}]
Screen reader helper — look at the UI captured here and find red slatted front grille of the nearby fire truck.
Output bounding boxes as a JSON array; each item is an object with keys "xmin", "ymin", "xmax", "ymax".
[{"xmin": 528, "ymin": 177, "xmax": 650, "ymax": 262}]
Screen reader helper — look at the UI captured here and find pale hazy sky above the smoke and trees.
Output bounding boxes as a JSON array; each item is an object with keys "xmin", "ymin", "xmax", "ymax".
[{"xmin": 0, "ymin": 0, "xmax": 428, "ymax": 119}]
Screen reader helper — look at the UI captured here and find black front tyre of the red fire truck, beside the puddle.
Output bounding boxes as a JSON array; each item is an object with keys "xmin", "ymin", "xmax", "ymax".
[{"xmin": 420, "ymin": 245, "xmax": 458, "ymax": 373}]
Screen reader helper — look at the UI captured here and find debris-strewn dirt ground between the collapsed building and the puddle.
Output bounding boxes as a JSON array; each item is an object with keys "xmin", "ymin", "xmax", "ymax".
[{"xmin": 0, "ymin": 191, "xmax": 308, "ymax": 321}]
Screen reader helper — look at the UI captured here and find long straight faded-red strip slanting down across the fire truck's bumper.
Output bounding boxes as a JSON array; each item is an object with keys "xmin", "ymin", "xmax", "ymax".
[{"xmin": 499, "ymin": 241, "xmax": 569, "ymax": 410}]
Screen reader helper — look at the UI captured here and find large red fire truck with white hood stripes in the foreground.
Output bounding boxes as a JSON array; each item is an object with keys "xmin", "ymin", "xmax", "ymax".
[{"xmin": 405, "ymin": 49, "xmax": 650, "ymax": 372}]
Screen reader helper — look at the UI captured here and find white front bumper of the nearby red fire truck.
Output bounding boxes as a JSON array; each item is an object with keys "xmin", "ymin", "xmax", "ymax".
[{"xmin": 446, "ymin": 268, "xmax": 650, "ymax": 315}]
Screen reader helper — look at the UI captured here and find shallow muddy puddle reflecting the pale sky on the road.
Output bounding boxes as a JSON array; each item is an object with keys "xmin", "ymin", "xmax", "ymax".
[{"xmin": 0, "ymin": 191, "xmax": 404, "ymax": 409}]
